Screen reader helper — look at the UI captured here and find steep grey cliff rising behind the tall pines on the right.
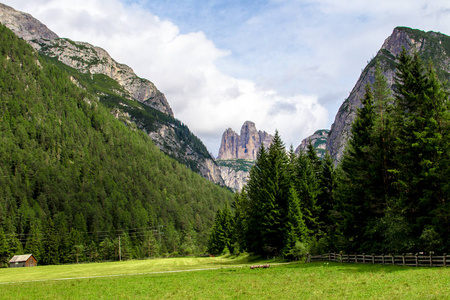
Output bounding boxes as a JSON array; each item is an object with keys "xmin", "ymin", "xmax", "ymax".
[{"xmin": 327, "ymin": 27, "xmax": 450, "ymax": 162}]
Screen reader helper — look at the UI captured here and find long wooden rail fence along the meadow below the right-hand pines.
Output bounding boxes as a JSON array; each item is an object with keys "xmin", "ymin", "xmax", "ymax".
[{"xmin": 306, "ymin": 253, "xmax": 450, "ymax": 267}]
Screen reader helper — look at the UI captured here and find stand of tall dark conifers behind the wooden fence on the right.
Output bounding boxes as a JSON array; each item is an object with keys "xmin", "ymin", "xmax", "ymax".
[{"xmin": 208, "ymin": 50, "xmax": 450, "ymax": 259}]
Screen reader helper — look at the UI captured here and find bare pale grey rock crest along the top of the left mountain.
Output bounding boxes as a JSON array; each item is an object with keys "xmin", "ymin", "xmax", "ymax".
[{"xmin": 0, "ymin": 4, "xmax": 173, "ymax": 117}]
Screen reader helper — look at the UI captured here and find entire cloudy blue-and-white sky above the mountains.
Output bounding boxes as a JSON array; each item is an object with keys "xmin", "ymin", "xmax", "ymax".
[{"xmin": 1, "ymin": 0, "xmax": 450, "ymax": 155}]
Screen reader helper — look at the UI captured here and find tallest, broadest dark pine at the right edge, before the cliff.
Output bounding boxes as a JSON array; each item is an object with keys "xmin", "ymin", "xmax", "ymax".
[{"xmin": 391, "ymin": 49, "xmax": 449, "ymax": 251}]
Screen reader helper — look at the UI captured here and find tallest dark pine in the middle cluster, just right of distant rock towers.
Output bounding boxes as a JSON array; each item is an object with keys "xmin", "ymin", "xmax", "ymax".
[{"xmin": 246, "ymin": 131, "xmax": 290, "ymax": 255}]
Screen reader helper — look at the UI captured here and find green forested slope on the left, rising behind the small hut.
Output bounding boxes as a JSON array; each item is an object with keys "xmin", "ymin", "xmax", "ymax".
[{"xmin": 0, "ymin": 26, "xmax": 232, "ymax": 266}]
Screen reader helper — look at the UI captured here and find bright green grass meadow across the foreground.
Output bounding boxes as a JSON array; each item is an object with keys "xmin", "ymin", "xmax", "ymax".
[{"xmin": 0, "ymin": 257, "xmax": 450, "ymax": 299}]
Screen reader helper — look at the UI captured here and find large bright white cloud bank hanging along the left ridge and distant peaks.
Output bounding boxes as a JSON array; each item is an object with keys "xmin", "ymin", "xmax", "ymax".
[{"xmin": 5, "ymin": 0, "xmax": 328, "ymax": 154}]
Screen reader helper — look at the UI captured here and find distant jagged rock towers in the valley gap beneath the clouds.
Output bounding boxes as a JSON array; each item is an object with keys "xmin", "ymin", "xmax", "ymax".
[{"xmin": 217, "ymin": 121, "xmax": 273, "ymax": 160}]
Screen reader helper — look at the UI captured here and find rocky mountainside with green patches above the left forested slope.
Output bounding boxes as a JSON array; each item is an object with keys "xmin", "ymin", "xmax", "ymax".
[{"xmin": 0, "ymin": 4, "xmax": 224, "ymax": 185}]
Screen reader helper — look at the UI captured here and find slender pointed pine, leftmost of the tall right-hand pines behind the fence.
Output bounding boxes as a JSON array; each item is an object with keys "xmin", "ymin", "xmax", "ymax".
[{"xmin": 337, "ymin": 85, "xmax": 377, "ymax": 252}]
